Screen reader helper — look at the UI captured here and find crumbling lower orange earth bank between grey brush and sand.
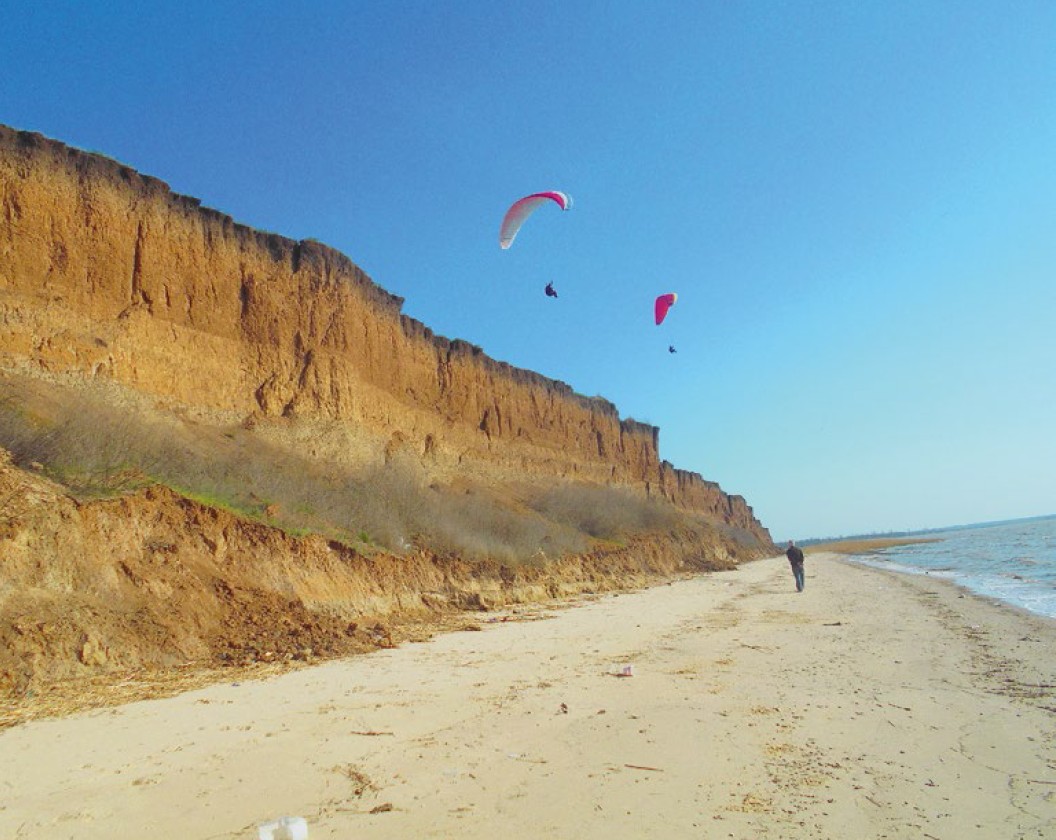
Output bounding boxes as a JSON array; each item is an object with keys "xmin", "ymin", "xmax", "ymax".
[{"xmin": 0, "ymin": 450, "xmax": 759, "ymax": 722}]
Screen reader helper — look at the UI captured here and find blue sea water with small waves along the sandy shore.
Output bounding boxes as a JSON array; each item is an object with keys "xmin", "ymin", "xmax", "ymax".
[{"xmin": 852, "ymin": 516, "xmax": 1056, "ymax": 618}]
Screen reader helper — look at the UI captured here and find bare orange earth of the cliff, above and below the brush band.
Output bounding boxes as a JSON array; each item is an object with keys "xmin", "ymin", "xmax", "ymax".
[{"xmin": 0, "ymin": 127, "xmax": 773, "ymax": 701}]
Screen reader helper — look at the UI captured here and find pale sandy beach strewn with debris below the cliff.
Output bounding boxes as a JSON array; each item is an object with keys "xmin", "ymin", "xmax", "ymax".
[{"xmin": 0, "ymin": 555, "xmax": 1056, "ymax": 840}]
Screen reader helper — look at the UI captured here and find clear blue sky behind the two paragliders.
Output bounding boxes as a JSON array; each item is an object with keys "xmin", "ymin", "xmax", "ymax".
[{"xmin": 0, "ymin": 0, "xmax": 1056, "ymax": 539}]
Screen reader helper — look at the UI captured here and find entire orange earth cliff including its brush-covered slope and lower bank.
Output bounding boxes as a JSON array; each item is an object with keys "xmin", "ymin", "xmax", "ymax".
[{"xmin": 0, "ymin": 127, "xmax": 773, "ymax": 714}]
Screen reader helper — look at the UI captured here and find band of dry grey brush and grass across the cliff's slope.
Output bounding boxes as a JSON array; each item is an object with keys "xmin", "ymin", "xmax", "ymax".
[{"xmin": 0, "ymin": 377, "xmax": 718, "ymax": 563}]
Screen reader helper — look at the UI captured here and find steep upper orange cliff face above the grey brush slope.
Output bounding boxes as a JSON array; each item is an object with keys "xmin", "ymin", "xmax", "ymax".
[{"xmin": 0, "ymin": 127, "xmax": 770, "ymax": 544}]
